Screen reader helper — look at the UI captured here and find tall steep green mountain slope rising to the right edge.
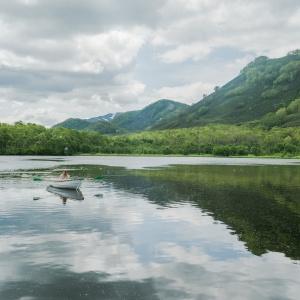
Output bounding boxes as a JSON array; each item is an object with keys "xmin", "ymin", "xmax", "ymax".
[{"xmin": 153, "ymin": 50, "xmax": 300, "ymax": 129}]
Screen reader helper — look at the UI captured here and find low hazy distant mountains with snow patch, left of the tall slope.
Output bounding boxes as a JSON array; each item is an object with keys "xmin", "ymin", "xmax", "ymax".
[{"xmin": 54, "ymin": 99, "xmax": 189, "ymax": 134}]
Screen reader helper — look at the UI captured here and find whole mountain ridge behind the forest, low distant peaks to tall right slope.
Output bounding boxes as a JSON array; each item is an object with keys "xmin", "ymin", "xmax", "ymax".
[{"xmin": 56, "ymin": 50, "xmax": 300, "ymax": 133}]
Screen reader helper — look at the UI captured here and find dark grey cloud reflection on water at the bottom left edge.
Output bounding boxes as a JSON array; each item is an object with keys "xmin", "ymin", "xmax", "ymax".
[{"xmin": 0, "ymin": 266, "xmax": 159, "ymax": 300}]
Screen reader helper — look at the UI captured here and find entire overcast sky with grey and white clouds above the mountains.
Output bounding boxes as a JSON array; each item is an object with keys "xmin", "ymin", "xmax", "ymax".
[{"xmin": 0, "ymin": 0, "xmax": 300, "ymax": 125}]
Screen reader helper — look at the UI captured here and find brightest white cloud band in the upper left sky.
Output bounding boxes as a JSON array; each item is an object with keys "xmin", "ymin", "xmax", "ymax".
[{"xmin": 0, "ymin": 29, "xmax": 146, "ymax": 73}]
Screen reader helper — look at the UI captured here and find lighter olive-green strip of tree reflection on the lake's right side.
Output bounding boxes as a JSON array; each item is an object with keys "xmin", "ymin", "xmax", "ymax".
[{"xmin": 135, "ymin": 166, "xmax": 300, "ymax": 216}]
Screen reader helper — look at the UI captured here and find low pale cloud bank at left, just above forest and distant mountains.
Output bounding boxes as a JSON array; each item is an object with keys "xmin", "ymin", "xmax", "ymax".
[{"xmin": 0, "ymin": 77, "xmax": 145, "ymax": 125}]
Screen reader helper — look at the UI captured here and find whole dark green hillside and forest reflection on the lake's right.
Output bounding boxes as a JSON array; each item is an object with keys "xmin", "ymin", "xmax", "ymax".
[{"xmin": 106, "ymin": 166, "xmax": 300, "ymax": 259}]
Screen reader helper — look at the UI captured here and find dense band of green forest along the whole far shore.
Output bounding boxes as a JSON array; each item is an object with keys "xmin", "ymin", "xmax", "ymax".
[{"xmin": 0, "ymin": 122, "xmax": 300, "ymax": 156}]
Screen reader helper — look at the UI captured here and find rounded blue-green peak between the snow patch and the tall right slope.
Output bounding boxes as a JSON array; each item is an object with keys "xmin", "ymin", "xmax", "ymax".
[{"xmin": 112, "ymin": 99, "xmax": 188, "ymax": 131}]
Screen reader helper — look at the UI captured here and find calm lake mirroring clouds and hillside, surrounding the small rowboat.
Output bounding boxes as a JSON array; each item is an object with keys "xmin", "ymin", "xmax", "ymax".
[{"xmin": 0, "ymin": 156, "xmax": 300, "ymax": 300}]
